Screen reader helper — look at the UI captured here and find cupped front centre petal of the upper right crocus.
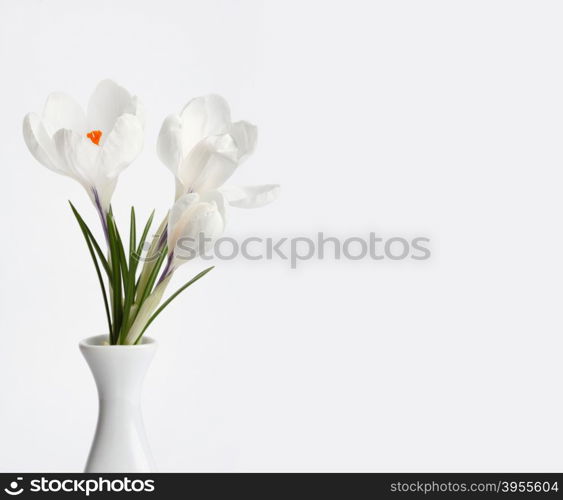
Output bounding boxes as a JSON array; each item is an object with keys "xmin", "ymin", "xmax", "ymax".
[{"xmin": 178, "ymin": 134, "xmax": 237, "ymax": 192}]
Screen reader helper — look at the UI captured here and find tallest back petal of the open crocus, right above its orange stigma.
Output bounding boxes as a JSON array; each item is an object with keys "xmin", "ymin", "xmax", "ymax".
[{"xmin": 87, "ymin": 80, "xmax": 140, "ymax": 138}]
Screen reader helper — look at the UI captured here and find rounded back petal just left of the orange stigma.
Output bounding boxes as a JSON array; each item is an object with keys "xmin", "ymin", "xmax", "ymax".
[{"xmin": 42, "ymin": 92, "xmax": 87, "ymax": 136}]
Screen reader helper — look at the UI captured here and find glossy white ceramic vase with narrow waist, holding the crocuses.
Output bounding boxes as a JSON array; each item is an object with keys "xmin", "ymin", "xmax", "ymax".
[{"xmin": 80, "ymin": 335, "xmax": 157, "ymax": 473}]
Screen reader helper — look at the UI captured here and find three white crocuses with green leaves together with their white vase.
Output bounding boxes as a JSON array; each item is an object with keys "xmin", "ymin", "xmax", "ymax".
[{"xmin": 23, "ymin": 80, "xmax": 279, "ymax": 472}]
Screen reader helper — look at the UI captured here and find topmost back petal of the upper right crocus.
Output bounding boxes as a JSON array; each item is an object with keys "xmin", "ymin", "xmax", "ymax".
[{"xmin": 180, "ymin": 94, "xmax": 231, "ymax": 157}]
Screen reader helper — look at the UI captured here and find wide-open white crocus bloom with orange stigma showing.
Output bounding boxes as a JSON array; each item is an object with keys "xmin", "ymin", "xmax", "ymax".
[{"xmin": 23, "ymin": 80, "xmax": 144, "ymax": 218}]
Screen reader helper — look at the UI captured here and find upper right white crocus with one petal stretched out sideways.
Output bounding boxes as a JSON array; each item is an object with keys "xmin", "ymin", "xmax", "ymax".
[{"xmin": 157, "ymin": 95, "xmax": 279, "ymax": 208}]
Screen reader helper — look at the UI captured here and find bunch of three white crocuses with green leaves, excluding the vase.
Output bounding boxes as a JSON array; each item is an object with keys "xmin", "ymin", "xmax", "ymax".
[{"xmin": 23, "ymin": 80, "xmax": 279, "ymax": 345}]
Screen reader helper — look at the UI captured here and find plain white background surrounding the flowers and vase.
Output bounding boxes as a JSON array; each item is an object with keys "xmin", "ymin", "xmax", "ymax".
[{"xmin": 0, "ymin": 0, "xmax": 563, "ymax": 471}]
